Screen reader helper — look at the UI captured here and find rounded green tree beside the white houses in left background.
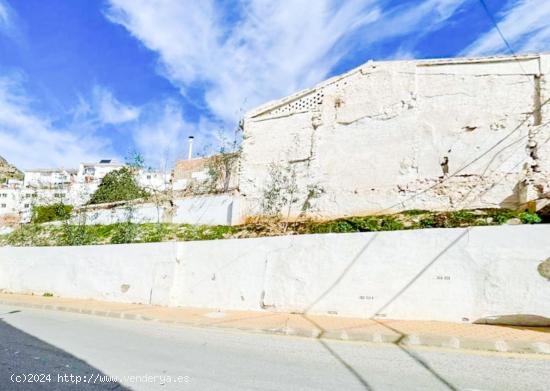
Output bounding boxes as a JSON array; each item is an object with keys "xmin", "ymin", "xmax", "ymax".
[{"xmin": 89, "ymin": 167, "xmax": 147, "ymax": 205}]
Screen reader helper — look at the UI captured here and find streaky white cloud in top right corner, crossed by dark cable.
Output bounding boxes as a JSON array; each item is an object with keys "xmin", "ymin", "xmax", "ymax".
[{"xmin": 464, "ymin": 0, "xmax": 550, "ymax": 56}]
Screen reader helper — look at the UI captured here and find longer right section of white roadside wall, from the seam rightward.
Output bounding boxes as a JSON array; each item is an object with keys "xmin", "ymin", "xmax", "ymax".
[{"xmin": 175, "ymin": 225, "xmax": 550, "ymax": 321}]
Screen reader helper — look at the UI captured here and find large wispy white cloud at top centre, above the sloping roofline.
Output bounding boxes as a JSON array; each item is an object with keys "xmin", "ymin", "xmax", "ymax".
[{"xmin": 106, "ymin": 0, "xmax": 467, "ymax": 123}]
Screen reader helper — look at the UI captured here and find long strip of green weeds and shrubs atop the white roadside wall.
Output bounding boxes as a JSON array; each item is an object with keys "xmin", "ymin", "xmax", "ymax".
[{"xmin": 0, "ymin": 205, "xmax": 542, "ymax": 246}]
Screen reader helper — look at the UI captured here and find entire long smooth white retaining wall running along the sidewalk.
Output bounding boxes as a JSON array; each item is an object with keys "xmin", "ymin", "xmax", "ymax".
[{"xmin": 0, "ymin": 225, "xmax": 550, "ymax": 324}]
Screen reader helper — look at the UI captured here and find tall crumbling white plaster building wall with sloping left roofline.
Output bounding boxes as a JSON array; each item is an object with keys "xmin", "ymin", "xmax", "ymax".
[{"xmin": 239, "ymin": 55, "xmax": 550, "ymax": 217}]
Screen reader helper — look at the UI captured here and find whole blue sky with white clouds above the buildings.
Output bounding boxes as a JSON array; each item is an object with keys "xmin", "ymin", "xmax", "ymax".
[{"xmin": 0, "ymin": 0, "xmax": 550, "ymax": 169}]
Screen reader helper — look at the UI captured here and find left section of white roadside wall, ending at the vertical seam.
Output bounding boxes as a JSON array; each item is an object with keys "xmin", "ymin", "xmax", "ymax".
[{"xmin": 0, "ymin": 243, "xmax": 175, "ymax": 305}]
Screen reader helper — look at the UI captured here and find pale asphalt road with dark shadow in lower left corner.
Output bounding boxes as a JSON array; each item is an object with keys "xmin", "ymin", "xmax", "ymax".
[{"xmin": 0, "ymin": 305, "xmax": 550, "ymax": 391}]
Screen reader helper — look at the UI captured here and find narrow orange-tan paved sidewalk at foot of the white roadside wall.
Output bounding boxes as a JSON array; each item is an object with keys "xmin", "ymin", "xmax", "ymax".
[{"xmin": 0, "ymin": 293, "xmax": 550, "ymax": 354}]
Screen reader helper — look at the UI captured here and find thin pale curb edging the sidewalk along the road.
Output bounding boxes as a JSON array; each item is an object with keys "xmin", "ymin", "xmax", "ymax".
[{"xmin": 0, "ymin": 299, "xmax": 550, "ymax": 355}]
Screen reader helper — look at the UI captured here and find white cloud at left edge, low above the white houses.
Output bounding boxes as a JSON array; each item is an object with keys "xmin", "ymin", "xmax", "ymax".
[{"xmin": 0, "ymin": 76, "xmax": 110, "ymax": 168}]
